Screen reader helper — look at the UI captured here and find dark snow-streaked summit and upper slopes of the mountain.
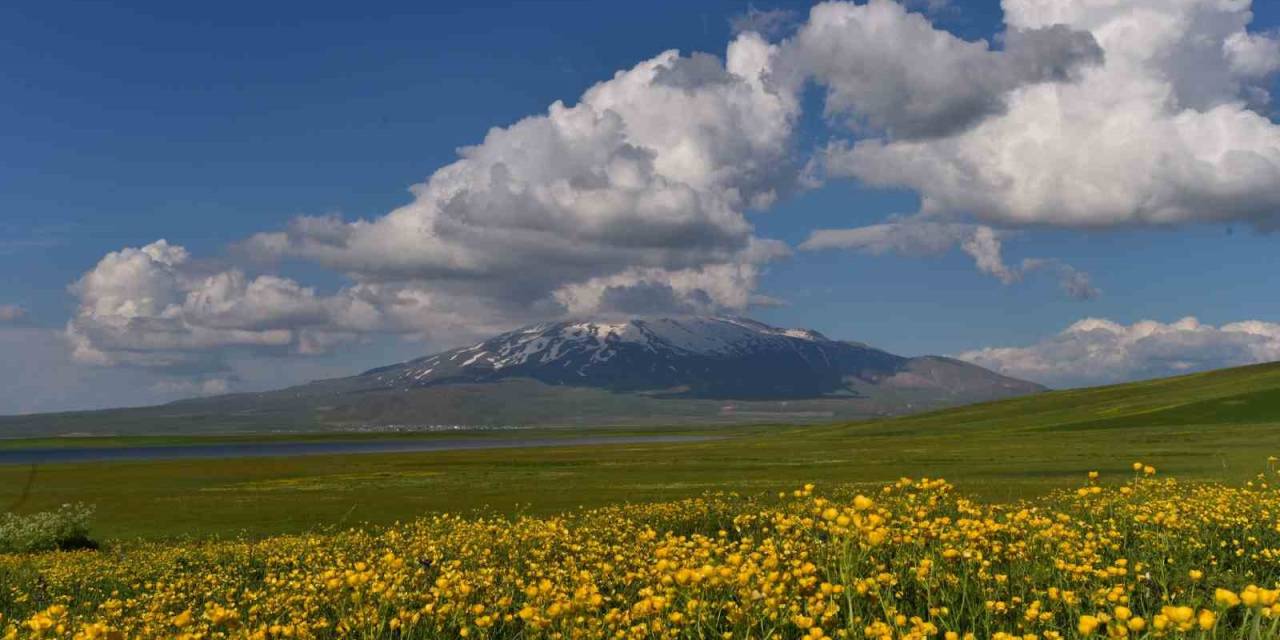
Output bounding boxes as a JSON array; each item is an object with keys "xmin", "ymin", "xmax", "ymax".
[{"xmin": 360, "ymin": 316, "xmax": 1038, "ymax": 399}]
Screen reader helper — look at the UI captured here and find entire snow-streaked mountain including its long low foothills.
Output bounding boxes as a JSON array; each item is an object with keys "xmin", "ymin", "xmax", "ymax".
[{"xmin": 0, "ymin": 316, "xmax": 1044, "ymax": 436}]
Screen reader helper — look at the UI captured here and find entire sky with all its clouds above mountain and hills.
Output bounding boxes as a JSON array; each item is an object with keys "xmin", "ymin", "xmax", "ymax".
[{"xmin": 0, "ymin": 0, "xmax": 1280, "ymax": 413}]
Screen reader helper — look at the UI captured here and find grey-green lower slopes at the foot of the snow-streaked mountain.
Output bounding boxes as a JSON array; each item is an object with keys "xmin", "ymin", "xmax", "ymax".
[{"xmin": 0, "ymin": 380, "xmax": 1018, "ymax": 438}]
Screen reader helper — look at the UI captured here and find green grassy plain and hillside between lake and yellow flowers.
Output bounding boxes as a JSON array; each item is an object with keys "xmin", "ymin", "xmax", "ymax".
[{"xmin": 0, "ymin": 365, "xmax": 1280, "ymax": 538}]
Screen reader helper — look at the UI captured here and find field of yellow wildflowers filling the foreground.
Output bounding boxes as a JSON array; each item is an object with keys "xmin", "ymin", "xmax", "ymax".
[{"xmin": 0, "ymin": 463, "xmax": 1280, "ymax": 640}]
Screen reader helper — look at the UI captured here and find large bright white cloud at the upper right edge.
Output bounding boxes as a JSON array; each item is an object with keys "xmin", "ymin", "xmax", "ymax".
[{"xmin": 824, "ymin": 0, "xmax": 1280, "ymax": 229}]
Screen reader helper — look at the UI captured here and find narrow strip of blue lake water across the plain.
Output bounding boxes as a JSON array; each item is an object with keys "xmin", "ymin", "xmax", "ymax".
[{"xmin": 0, "ymin": 435, "xmax": 712, "ymax": 465}]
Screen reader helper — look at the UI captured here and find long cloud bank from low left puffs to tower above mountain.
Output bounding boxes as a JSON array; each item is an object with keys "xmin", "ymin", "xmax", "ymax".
[{"xmin": 67, "ymin": 33, "xmax": 801, "ymax": 384}]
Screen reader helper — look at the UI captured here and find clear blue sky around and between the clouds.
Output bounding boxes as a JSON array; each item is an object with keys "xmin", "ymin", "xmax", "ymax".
[{"xmin": 0, "ymin": 0, "xmax": 1280, "ymax": 413}]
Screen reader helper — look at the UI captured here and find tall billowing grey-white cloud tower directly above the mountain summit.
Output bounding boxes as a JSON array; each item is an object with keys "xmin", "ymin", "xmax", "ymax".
[{"xmin": 243, "ymin": 32, "xmax": 799, "ymax": 315}]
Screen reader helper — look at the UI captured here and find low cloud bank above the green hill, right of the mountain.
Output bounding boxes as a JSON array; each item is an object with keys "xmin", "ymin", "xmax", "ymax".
[{"xmin": 957, "ymin": 317, "xmax": 1280, "ymax": 387}]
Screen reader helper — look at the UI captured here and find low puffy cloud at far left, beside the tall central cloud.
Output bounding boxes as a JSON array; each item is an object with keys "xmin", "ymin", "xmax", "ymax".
[{"xmin": 67, "ymin": 239, "xmax": 455, "ymax": 375}]
